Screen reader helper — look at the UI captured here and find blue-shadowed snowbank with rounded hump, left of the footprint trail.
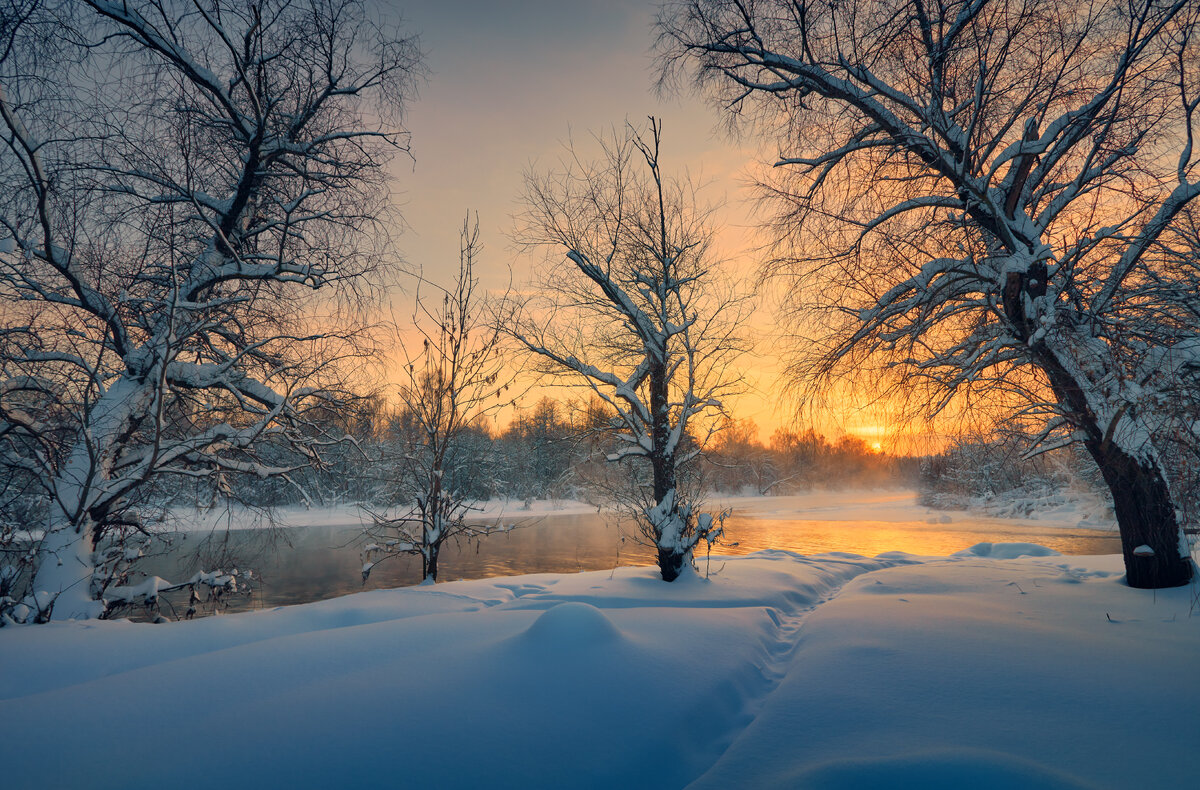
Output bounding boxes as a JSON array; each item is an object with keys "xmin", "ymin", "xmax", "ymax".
[{"xmin": 0, "ymin": 552, "xmax": 890, "ymax": 790}]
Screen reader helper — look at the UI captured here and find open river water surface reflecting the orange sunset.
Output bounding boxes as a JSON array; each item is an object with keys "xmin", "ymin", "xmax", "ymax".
[{"xmin": 136, "ymin": 501, "xmax": 1121, "ymax": 615}]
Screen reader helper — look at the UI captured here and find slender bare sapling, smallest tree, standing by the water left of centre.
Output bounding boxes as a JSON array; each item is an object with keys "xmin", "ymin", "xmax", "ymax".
[{"xmin": 362, "ymin": 212, "xmax": 508, "ymax": 582}]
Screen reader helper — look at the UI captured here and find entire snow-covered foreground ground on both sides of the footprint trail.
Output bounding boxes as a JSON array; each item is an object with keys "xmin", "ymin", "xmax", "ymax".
[{"xmin": 0, "ymin": 546, "xmax": 1200, "ymax": 790}]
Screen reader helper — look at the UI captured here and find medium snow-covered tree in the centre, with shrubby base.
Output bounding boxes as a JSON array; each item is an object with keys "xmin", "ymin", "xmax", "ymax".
[{"xmin": 515, "ymin": 118, "xmax": 743, "ymax": 581}]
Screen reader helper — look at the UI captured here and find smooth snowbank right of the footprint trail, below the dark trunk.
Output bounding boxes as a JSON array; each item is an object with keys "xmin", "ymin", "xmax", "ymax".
[{"xmin": 692, "ymin": 557, "xmax": 1200, "ymax": 790}]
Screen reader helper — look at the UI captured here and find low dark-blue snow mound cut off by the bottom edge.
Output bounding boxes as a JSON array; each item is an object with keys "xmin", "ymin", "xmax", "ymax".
[{"xmin": 788, "ymin": 749, "xmax": 1092, "ymax": 790}]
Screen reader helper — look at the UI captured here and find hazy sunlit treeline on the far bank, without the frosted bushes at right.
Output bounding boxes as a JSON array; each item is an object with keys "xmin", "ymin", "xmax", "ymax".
[{"xmin": 192, "ymin": 397, "xmax": 922, "ymax": 508}]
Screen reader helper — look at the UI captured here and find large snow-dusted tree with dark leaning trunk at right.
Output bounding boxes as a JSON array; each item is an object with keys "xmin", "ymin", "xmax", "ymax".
[{"xmin": 660, "ymin": 0, "xmax": 1200, "ymax": 587}]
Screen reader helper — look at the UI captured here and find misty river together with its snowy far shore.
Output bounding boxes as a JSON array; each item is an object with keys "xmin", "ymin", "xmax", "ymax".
[{"xmin": 150, "ymin": 491, "xmax": 1121, "ymax": 615}]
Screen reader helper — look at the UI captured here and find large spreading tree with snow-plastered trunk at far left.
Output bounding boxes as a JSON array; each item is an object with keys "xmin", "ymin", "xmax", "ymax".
[{"xmin": 0, "ymin": 0, "xmax": 420, "ymax": 621}]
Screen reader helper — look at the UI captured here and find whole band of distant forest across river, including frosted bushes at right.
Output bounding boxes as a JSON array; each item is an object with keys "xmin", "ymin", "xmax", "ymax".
[{"xmin": 140, "ymin": 397, "xmax": 1123, "ymax": 515}]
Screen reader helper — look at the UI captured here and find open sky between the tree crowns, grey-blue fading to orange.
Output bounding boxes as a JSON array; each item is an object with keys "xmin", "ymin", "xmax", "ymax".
[{"xmin": 379, "ymin": 0, "xmax": 902, "ymax": 443}]
